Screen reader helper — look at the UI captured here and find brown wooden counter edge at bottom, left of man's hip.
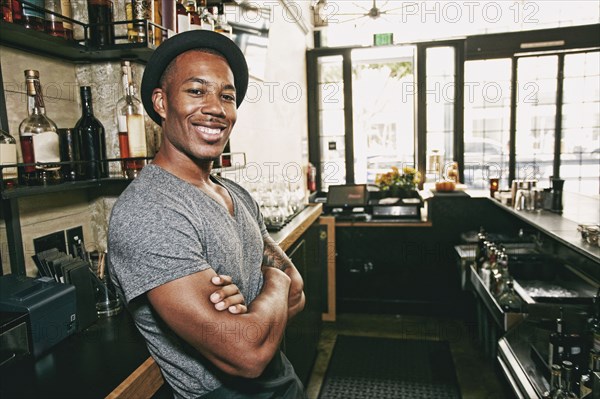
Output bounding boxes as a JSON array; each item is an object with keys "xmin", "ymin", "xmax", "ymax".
[{"xmin": 106, "ymin": 356, "xmax": 165, "ymax": 399}]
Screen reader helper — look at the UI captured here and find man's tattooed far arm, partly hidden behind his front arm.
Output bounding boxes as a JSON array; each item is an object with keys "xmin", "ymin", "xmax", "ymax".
[{"xmin": 263, "ymin": 237, "xmax": 306, "ymax": 320}]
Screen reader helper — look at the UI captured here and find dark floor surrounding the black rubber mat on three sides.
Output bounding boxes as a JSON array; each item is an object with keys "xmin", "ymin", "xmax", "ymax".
[{"xmin": 307, "ymin": 314, "xmax": 513, "ymax": 399}]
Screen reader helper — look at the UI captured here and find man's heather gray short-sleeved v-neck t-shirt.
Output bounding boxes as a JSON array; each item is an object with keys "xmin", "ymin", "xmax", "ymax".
[{"xmin": 108, "ymin": 165, "xmax": 286, "ymax": 397}]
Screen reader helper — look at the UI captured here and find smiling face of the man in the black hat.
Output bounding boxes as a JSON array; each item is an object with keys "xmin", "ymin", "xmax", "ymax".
[{"xmin": 153, "ymin": 51, "xmax": 237, "ymax": 161}]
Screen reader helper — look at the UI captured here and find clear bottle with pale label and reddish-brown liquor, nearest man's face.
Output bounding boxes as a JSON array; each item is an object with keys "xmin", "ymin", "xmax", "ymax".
[{"xmin": 117, "ymin": 61, "xmax": 146, "ymax": 179}]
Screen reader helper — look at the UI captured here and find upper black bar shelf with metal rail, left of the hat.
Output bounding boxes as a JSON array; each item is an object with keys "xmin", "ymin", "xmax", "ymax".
[{"xmin": 0, "ymin": 0, "xmax": 167, "ymax": 62}]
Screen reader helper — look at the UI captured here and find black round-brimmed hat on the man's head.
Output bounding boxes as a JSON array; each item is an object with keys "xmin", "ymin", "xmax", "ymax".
[{"xmin": 141, "ymin": 30, "xmax": 248, "ymax": 125}]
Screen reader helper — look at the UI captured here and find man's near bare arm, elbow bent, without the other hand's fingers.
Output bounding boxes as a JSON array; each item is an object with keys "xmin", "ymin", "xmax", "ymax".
[{"xmin": 147, "ymin": 268, "xmax": 290, "ymax": 378}]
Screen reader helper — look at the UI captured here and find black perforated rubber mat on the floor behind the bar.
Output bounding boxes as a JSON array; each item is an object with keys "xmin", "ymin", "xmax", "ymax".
[{"xmin": 319, "ymin": 335, "xmax": 461, "ymax": 399}]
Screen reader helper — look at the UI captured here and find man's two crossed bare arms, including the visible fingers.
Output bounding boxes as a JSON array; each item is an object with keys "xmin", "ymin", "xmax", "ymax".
[{"xmin": 148, "ymin": 236, "xmax": 305, "ymax": 378}]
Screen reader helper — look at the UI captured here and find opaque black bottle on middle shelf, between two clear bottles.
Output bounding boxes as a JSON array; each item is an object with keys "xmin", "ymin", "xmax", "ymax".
[{"xmin": 75, "ymin": 86, "xmax": 108, "ymax": 179}]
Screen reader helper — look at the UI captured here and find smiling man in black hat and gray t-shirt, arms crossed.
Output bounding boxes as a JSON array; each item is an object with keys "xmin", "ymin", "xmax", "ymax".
[{"xmin": 108, "ymin": 31, "xmax": 305, "ymax": 398}]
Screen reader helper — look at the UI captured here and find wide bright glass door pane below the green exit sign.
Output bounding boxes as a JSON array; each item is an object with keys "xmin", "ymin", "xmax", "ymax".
[{"xmin": 351, "ymin": 46, "xmax": 415, "ymax": 184}]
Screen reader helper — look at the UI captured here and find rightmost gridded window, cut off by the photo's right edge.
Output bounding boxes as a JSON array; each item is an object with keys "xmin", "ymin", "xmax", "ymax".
[{"xmin": 560, "ymin": 51, "xmax": 600, "ymax": 194}]
